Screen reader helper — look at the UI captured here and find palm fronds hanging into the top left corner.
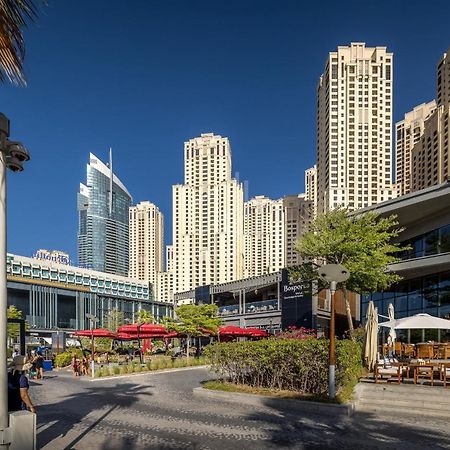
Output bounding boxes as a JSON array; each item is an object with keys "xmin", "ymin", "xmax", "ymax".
[{"xmin": 0, "ymin": 0, "xmax": 36, "ymax": 85}]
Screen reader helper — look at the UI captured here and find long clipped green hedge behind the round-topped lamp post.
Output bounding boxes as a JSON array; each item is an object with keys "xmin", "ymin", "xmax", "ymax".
[{"xmin": 205, "ymin": 338, "xmax": 362, "ymax": 395}]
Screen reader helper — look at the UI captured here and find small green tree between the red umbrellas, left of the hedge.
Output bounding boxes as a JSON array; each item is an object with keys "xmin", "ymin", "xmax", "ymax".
[{"xmin": 164, "ymin": 304, "xmax": 222, "ymax": 357}]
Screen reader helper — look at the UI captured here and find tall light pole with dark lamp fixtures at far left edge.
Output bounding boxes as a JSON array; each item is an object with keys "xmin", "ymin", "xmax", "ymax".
[{"xmin": 0, "ymin": 113, "xmax": 30, "ymax": 446}]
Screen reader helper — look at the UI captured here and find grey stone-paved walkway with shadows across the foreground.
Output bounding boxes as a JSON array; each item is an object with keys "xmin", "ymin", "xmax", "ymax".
[{"xmin": 30, "ymin": 368, "xmax": 450, "ymax": 450}]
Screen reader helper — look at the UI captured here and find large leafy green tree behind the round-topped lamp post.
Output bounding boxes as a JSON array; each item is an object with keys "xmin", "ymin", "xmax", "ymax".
[{"xmin": 291, "ymin": 209, "xmax": 407, "ymax": 337}]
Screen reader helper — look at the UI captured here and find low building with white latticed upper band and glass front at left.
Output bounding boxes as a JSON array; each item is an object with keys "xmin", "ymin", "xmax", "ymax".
[{"xmin": 7, "ymin": 254, "xmax": 173, "ymax": 331}]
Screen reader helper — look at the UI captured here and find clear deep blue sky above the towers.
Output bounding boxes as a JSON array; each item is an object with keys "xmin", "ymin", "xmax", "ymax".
[{"xmin": 0, "ymin": 0, "xmax": 450, "ymax": 260}]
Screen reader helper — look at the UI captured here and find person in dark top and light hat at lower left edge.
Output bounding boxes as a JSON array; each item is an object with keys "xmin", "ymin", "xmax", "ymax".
[{"xmin": 8, "ymin": 355, "xmax": 36, "ymax": 413}]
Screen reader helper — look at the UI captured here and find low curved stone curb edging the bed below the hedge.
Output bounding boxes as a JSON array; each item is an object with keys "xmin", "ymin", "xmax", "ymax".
[{"xmin": 193, "ymin": 387, "xmax": 355, "ymax": 417}]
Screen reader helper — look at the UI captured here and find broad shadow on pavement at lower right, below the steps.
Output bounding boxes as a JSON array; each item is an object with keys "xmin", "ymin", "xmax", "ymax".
[{"xmin": 247, "ymin": 399, "xmax": 450, "ymax": 450}]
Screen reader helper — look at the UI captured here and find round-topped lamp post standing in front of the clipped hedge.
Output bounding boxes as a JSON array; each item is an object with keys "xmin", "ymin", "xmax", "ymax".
[{"xmin": 317, "ymin": 264, "xmax": 350, "ymax": 398}]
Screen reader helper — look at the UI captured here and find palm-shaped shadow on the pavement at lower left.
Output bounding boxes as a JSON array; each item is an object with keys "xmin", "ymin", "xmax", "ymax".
[{"xmin": 37, "ymin": 383, "xmax": 153, "ymax": 449}]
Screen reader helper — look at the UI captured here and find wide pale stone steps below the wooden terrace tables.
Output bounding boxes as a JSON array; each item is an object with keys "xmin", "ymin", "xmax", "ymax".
[{"xmin": 354, "ymin": 382, "xmax": 450, "ymax": 417}]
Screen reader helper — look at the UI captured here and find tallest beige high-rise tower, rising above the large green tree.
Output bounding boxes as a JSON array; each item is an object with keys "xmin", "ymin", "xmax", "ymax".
[{"xmin": 317, "ymin": 42, "xmax": 394, "ymax": 214}]
